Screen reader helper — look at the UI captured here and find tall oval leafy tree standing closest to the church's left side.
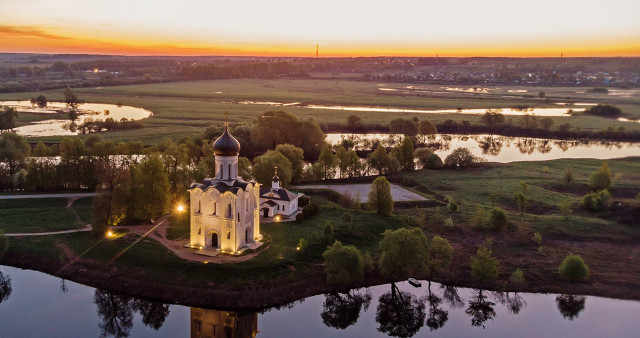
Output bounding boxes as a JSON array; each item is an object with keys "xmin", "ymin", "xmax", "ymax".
[{"xmin": 130, "ymin": 154, "xmax": 171, "ymax": 221}]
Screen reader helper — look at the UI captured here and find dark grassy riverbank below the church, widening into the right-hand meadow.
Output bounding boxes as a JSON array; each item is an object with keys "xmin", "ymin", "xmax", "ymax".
[{"xmin": 0, "ymin": 157, "xmax": 640, "ymax": 309}]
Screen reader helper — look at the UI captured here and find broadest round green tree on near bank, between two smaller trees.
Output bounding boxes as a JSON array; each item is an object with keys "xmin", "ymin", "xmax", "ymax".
[{"xmin": 378, "ymin": 228, "xmax": 429, "ymax": 279}]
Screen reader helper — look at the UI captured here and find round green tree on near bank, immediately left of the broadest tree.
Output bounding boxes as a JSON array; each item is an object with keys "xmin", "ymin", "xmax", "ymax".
[{"xmin": 322, "ymin": 241, "xmax": 364, "ymax": 286}]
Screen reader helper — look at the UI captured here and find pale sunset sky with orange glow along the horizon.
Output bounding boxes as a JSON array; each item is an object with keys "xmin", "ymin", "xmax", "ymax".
[{"xmin": 0, "ymin": 0, "xmax": 640, "ymax": 56}]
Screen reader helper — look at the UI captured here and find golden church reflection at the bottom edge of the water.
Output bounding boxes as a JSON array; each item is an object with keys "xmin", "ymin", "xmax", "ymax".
[{"xmin": 191, "ymin": 307, "xmax": 258, "ymax": 338}]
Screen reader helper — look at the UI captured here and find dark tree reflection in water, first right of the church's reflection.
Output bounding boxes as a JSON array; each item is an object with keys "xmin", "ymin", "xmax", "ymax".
[{"xmin": 320, "ymin": 291, "xmax": 371, "ymax": 329}]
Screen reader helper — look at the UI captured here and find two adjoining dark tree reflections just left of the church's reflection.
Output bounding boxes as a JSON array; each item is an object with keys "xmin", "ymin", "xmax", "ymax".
[{"xmin": 94, "ymin": 289, "xmax": 169, "ymax": 337}]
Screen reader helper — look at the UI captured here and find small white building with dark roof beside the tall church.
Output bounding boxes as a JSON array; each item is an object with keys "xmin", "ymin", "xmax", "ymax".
[{"xmin": 260, "ymin": 167, "xmax": 303, "ymax": 218}]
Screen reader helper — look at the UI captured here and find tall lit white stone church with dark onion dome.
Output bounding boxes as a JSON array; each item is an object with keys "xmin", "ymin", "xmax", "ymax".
[{"xmin": 189, "ymin": 125, "xmax": 261, "ymax": 253}]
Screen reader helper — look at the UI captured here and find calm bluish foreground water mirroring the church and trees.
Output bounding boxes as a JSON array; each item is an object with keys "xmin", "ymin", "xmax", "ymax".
[{"xmin": 0, "ymin": 266, "xmax": 640, "ymax": 337}]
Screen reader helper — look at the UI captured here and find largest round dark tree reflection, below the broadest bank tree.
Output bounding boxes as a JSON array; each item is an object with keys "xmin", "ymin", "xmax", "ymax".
[{"xmin": 376, "ymin": 284, "xmax": 425, "ymax": 337}]
